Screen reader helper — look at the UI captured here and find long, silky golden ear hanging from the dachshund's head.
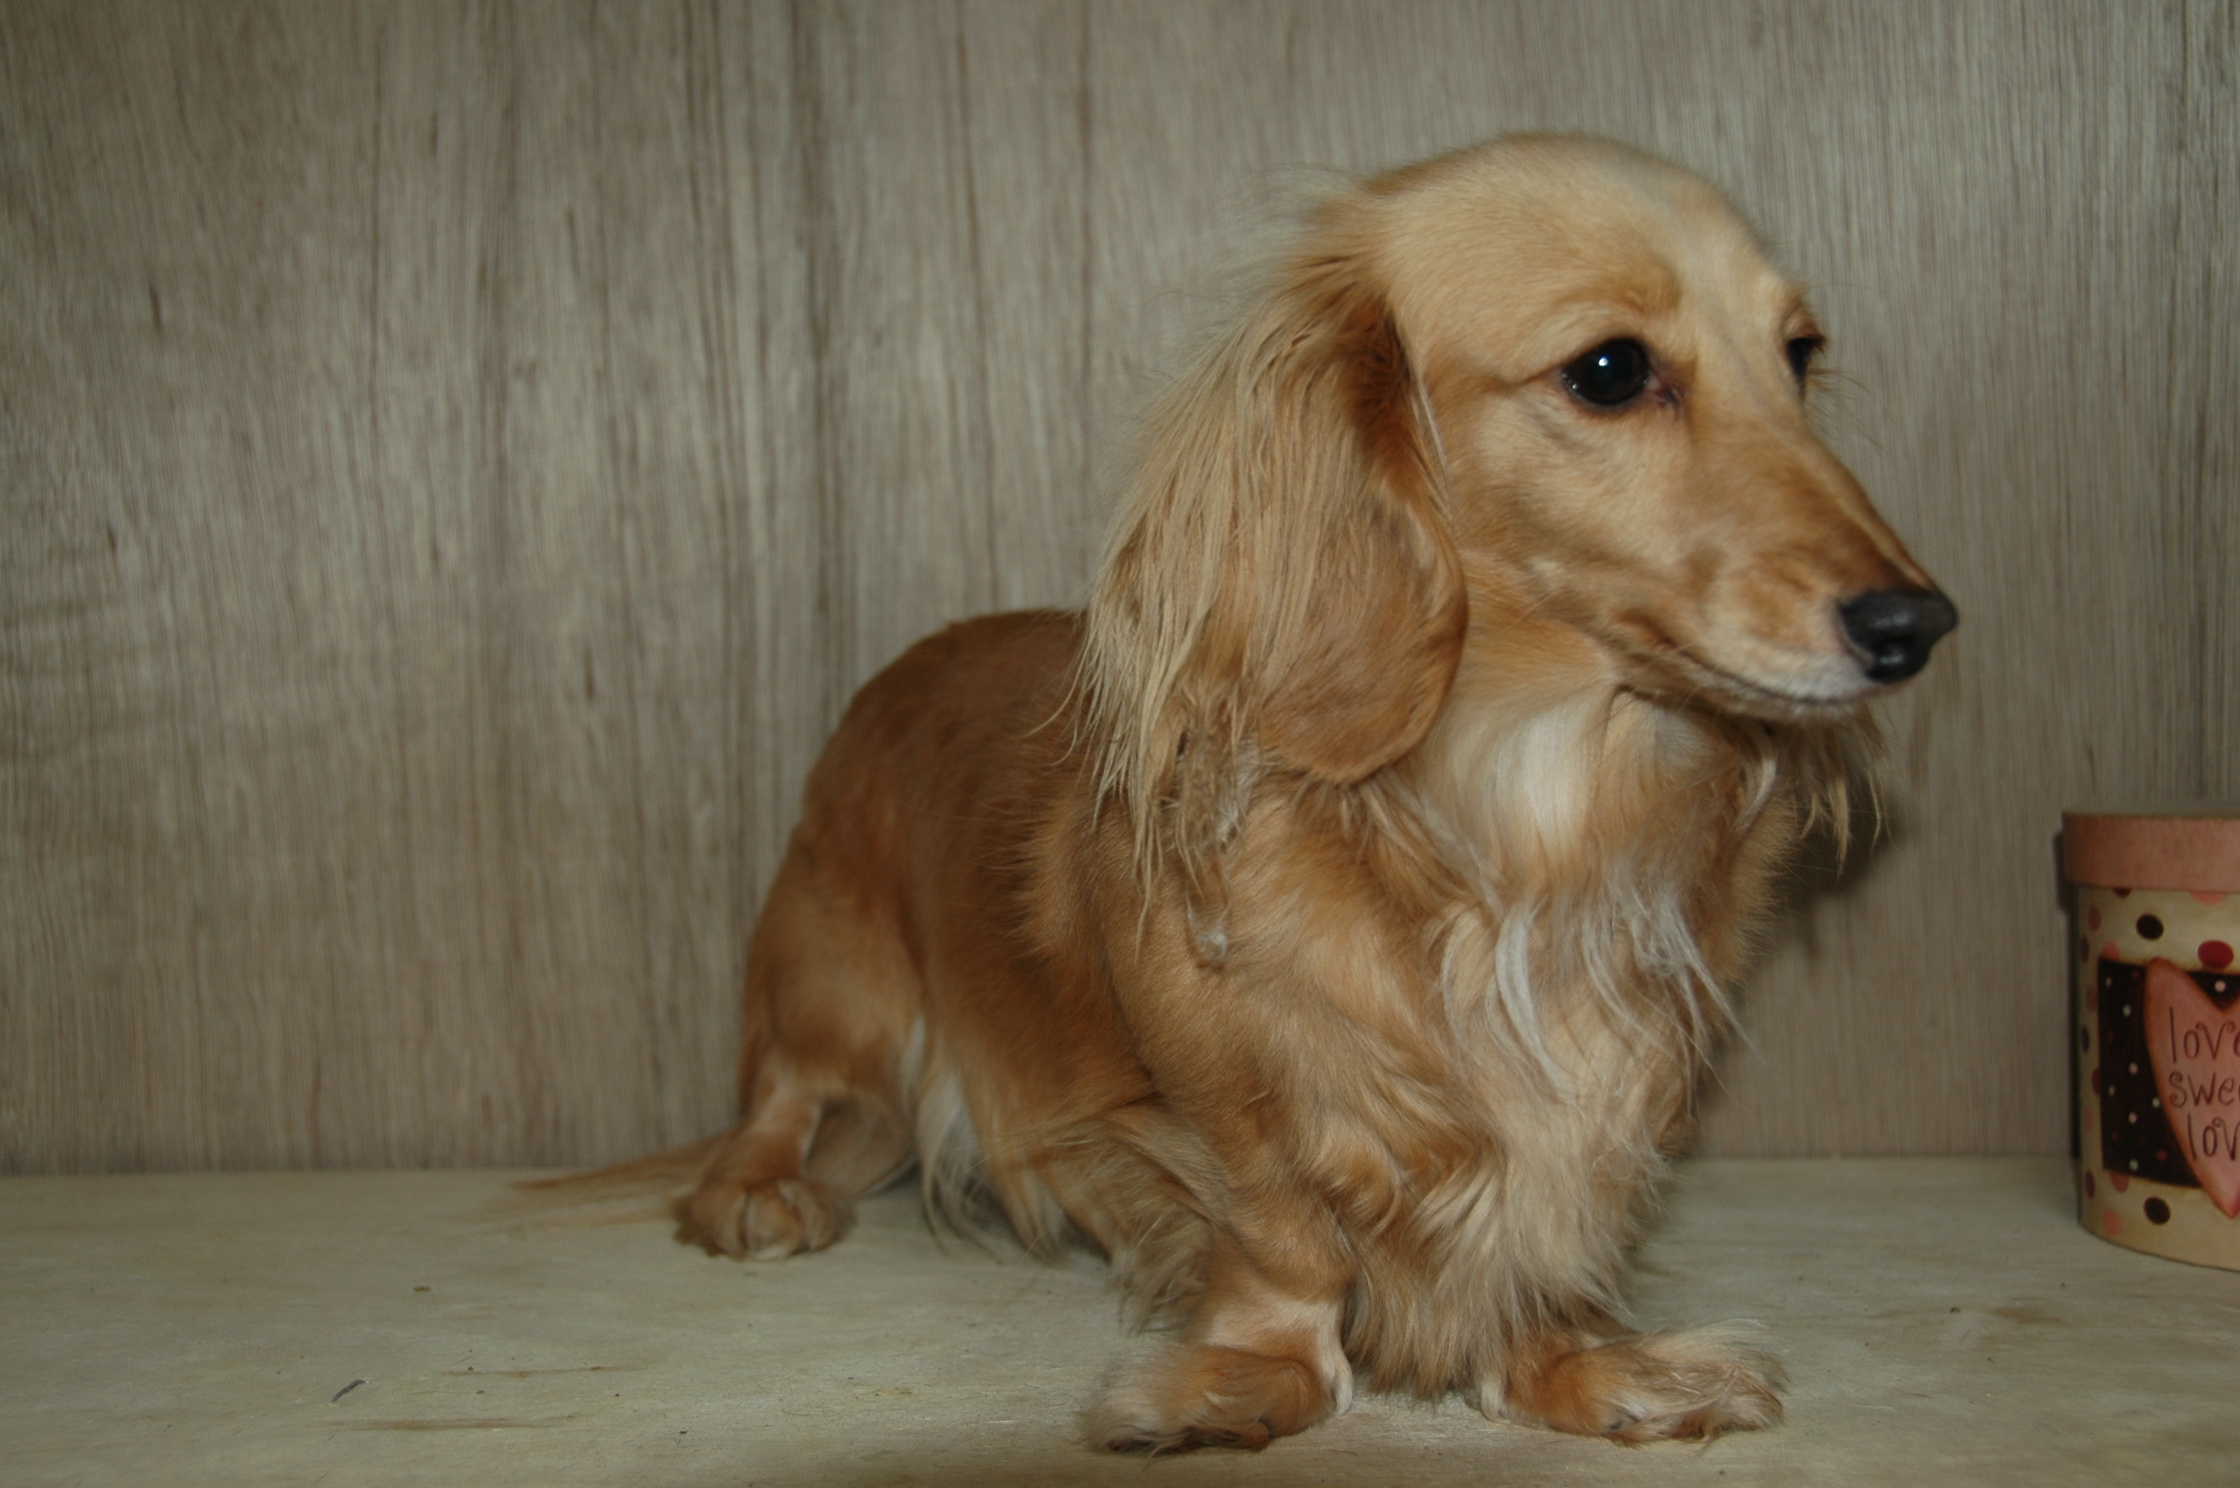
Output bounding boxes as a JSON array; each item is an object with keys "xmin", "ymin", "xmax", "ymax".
[{"xmin": 1084, "ymin": 222, "xmax": 1469, "ymax": 858}]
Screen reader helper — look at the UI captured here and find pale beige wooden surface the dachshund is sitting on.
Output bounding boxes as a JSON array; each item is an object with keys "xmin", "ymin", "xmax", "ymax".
[{"xmin": 0, "ymin": 1159, "xmax": 2240, "ymax": 1488}]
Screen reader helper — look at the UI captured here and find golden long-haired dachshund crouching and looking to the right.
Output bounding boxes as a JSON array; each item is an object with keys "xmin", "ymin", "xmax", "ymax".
[{"xmin": 679, "ymin": 137, "xmax": 1956, "ymax": 1450}]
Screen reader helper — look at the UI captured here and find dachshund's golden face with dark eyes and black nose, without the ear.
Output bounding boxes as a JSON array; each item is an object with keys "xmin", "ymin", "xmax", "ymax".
[{"xmin": 1351, "ymin": 139, "xmax": 1956, "ymax": 719}]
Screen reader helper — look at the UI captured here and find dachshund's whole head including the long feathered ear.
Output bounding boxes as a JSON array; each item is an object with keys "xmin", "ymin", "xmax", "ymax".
[{"xmin": 1089, "ymin": 137, "xmax": 1956, "ymax": 856}]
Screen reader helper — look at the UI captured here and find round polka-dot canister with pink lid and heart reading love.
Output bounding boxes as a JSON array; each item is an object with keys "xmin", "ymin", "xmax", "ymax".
[{"xmin": 2061, "ymin": 805, "xmax": 2240, "ymax": 1271}]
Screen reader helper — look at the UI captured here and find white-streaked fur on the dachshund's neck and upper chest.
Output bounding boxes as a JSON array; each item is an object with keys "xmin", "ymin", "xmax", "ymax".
[{"xmin": 1404, "ymin": 623, "xmax": 1776, "ymax": 1098}]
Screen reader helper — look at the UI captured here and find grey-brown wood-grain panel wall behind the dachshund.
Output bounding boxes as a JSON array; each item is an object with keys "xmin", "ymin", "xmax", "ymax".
[{"xmin": 0, "ymin": 0, "xmax": 2240, "ymax": 1172}]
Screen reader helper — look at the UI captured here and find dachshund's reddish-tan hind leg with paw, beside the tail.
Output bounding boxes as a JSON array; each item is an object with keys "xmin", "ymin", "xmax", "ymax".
[{"xmin": 676, "ymin": 836, "xmax": 921, "ymax": 1259}]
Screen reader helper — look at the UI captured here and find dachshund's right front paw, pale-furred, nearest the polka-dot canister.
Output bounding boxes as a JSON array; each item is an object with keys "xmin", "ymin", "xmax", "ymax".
[{"xmin": 1483, "ymin": 1329, "xmax": 1788, "ymax": 1443}]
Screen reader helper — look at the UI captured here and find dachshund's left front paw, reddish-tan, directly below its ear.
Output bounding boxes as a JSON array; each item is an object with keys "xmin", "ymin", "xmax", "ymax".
[{"xmin": 1089, "ymin": 1342, "xmax": 1335, "ymax": 1452}]
